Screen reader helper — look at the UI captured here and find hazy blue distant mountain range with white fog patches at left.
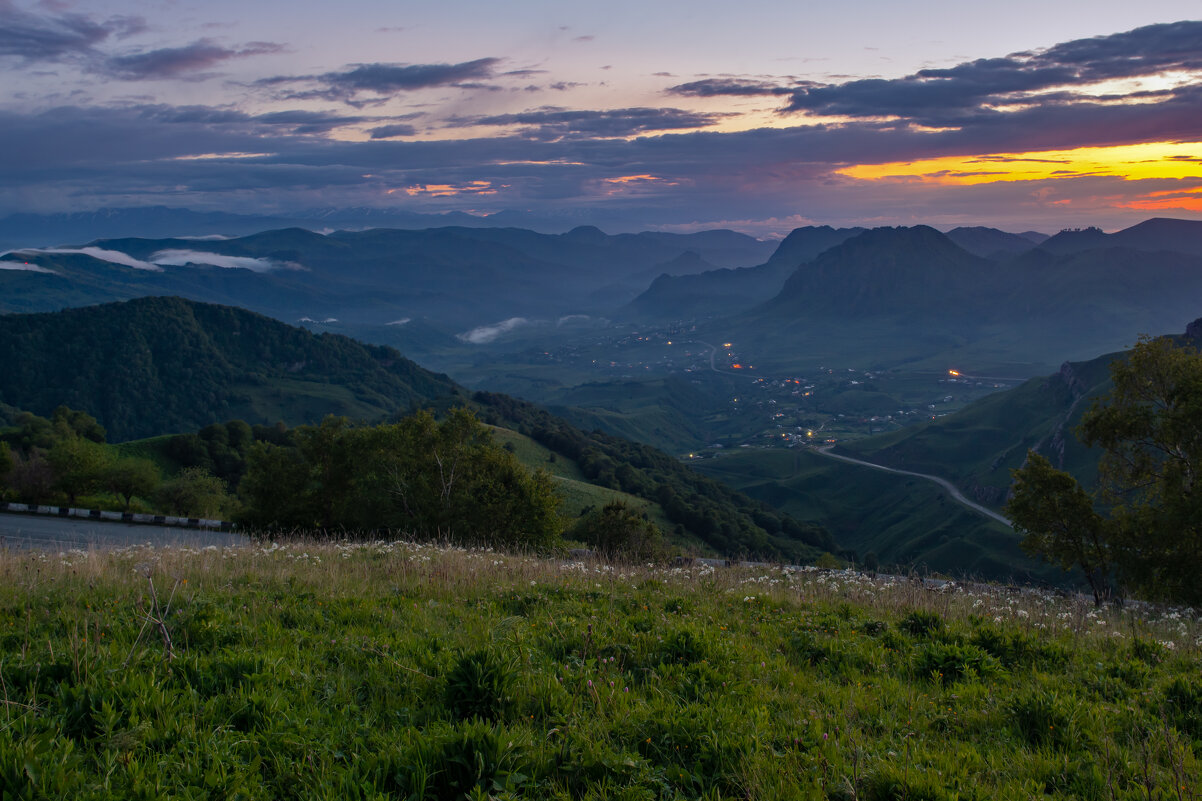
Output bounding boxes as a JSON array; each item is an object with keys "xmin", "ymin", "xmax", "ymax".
[{"xmin": 0, "ymin": 226, "xmax": 775, "ymax": 333}]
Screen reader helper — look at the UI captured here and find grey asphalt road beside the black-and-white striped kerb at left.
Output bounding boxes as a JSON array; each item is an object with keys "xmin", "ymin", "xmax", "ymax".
[{"xmin": 0, "ymin": 514, "xmax": 250, "ymax": 551}]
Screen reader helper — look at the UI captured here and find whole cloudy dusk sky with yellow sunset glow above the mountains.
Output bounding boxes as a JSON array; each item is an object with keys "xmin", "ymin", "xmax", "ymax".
[{"xmin": 0, "ymin": 0, "xmax": 1202, "ymax": 236}]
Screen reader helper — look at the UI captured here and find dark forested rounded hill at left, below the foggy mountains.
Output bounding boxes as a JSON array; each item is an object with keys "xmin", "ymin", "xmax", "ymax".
[{"xmin": 0, "ymin": 297, "xmax": 456, "ymax": 440}]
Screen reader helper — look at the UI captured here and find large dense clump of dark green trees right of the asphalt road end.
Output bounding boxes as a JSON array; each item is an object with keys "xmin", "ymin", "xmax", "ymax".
[{"xmin": 239, "ymin": 409, "xmax": 559, "ymax": 548}]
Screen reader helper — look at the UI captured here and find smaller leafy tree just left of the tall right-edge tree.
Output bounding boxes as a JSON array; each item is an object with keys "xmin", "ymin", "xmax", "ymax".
[{"xmin": 1006, "ymin": 451, "xmax": 1111, "ymax": 604}]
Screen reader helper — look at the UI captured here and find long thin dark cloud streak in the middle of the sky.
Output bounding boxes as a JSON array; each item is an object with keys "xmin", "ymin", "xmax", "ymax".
[{"xmin": 450, "ymin": 106, "xmax": 726, "ymax": 140}]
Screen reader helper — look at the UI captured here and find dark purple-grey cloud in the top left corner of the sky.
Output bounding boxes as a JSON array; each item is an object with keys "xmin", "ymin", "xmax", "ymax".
[{"xmin": 0, "ymin": 0, "xmax": 145, "ymax": 63}]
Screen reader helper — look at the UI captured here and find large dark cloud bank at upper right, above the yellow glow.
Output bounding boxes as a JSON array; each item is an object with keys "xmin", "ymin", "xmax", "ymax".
[{"xmin": 785, "ymin": 22, "xmax": 1202, "ymax": 125}]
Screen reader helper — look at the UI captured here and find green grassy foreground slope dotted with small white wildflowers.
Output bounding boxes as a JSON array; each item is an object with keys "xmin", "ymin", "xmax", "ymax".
[{"xmin": 0, "ymin": 542, "xmax": 1202, "ymax": 801}]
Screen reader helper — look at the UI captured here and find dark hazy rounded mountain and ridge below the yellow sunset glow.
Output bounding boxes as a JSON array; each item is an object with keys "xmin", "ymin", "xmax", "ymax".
[{"xmin": 706, "ymin": 220, "xmax": 1202, "ymax": 375}]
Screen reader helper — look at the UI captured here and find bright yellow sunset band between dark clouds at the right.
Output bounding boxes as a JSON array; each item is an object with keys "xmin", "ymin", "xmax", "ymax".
[{"xmin": 838, "ymin": 142, "xmax": 1202, "ymax": 185}]
